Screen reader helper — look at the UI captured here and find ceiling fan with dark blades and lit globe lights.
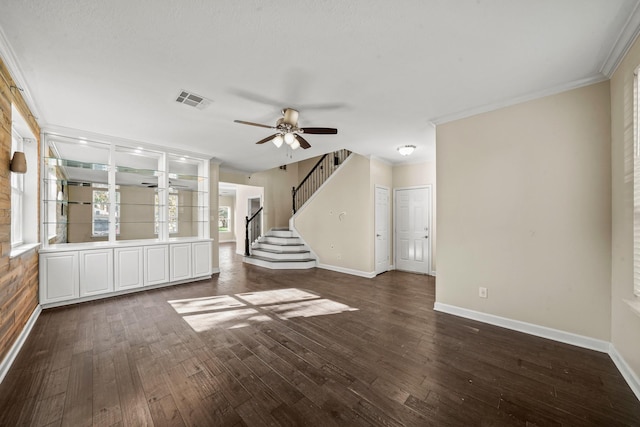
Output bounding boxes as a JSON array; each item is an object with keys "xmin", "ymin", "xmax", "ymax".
[{"xmin": 234, "ymin": 108, "xmax": 338, "ymax": 150}]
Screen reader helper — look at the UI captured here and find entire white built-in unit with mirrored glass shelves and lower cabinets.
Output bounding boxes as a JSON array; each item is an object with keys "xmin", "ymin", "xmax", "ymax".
[{"xmin": 40, "ymin": 133, "xmax": 212, "ymax": 307}]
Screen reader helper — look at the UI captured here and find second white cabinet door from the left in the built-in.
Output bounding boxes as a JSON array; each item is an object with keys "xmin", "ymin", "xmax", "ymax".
[{"xmin": 80, "ymin": 249, "xmax": 113, "ymax": 297}]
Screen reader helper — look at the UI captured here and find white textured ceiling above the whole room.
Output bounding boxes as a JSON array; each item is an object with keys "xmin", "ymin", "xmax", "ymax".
[{"xmin": 0, "ymin": 0, "xmax": 638, "ymax": 172}]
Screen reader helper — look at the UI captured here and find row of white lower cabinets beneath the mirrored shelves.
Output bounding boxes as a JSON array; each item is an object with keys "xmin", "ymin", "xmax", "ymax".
[{"xmin": 40, "ymin": 239, "xmax": 211, "ymax": 307}]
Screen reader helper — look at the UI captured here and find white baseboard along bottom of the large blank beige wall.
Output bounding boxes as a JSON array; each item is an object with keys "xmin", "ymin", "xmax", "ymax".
[{"xmin": 433, "ymin": 302, "xmax": 610, "ymax": 353}]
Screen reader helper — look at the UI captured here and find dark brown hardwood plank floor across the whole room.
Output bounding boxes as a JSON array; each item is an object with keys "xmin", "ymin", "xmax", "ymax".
[{"xmin": 0, "ymin": 244, "xmax": 640, "ymax": 426}]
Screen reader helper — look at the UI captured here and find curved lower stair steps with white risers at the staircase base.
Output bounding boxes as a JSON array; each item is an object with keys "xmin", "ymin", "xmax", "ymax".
[{"xmin": 244, "ymin": 228, "xmax": 316, "ymax": 270}]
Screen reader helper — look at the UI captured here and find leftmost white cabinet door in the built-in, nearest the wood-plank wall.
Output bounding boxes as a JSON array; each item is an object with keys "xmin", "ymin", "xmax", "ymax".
[{"xmin": 40, "ymin": 251, "xmax": 80, "ymax": 304}]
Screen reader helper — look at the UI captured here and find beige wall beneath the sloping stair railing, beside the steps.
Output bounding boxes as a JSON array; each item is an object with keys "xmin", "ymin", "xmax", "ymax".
[{"xmin": 295, "ymin": 154, "xmax": 374, "ymax": 273}]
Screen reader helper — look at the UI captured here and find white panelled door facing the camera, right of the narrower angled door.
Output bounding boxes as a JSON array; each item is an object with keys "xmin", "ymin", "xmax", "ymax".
[{"xmin": 395, "ymin": 187, "xmax": 431, "ymax": 274}]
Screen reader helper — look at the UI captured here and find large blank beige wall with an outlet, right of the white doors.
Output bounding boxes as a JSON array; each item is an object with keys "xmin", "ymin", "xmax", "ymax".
[{"xmin": 436, "ymin": 82, "xmax": 612, "ymax": 342}]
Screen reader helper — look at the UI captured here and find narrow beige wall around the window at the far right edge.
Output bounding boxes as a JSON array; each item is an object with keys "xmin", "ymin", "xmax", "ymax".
[{"xmin": 611, "ymin": 35, "xmax": 640, "ymax": 377}]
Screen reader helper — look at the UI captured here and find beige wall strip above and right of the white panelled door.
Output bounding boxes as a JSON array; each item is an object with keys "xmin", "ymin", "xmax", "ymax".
[{"xmin": 393, "ymin": 162, "xmax": 437, "ymax": 272}]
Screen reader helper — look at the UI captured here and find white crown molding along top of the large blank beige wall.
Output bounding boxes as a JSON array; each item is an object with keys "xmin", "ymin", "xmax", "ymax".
[{"xmin": 429, "ymin": 73, "xmax": 609, "ymax": 126}]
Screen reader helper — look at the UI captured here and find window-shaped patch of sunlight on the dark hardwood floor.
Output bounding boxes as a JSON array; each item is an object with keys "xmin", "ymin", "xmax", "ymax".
[{"xmin": 168, "ymin": 288, "xmax": 358, "ymax": 332}]
